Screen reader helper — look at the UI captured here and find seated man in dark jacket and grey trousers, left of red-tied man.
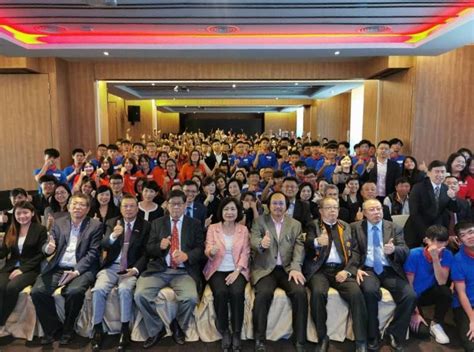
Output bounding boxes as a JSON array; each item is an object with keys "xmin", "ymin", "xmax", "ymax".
[{"xmin": 91, "ymin": 194, "xmax": 150, "ymax": 351}]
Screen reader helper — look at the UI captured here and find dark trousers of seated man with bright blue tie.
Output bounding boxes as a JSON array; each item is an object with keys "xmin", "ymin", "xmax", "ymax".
[{"xmin": 360, "ymin": 267, "xmax": 416, "ymax": 341}]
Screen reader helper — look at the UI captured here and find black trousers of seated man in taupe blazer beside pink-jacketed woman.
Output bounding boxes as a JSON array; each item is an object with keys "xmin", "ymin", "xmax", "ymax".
[{"xmin": 253, "ymin": 266, "xmax": 308, "ymax": 344}]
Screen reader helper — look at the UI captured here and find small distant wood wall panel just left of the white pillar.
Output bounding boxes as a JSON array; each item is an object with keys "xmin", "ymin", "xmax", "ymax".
[{"xmin": 311, "ymin": 93, "xmax": 351, "ymax": 141}]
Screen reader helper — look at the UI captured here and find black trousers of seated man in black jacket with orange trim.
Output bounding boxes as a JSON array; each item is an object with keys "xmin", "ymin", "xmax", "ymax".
[{"xmin": 308, "ymin": 267, "xmax": 368, "ymax": 341}]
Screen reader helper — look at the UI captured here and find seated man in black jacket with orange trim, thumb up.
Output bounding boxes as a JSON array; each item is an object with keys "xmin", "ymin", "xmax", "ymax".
[{"xmin": 303, "ymin": 198, "xmax": 367, "ymax": 352}]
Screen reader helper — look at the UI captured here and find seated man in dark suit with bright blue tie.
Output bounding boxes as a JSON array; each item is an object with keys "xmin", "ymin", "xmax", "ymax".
[{"xmin": 351, "ymin": 199, "xmax": 416, "ymax": 351}]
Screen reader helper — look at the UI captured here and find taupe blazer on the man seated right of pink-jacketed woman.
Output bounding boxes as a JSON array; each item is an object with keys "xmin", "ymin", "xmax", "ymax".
[{"xmin": 250, "ymin": 214, "xmax": 304, "ymax": 285}]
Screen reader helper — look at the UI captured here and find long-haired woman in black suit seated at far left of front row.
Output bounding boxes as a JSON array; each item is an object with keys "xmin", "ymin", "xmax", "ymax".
[{"xmin": 0, "ymin": 201, "xmax": 48, "ymax": 327}]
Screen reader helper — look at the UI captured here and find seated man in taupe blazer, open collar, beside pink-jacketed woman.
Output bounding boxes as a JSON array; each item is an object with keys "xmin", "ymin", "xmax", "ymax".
[{"xmin": 250, "ymin": 192, "xmax": 308, "ymax": 352}]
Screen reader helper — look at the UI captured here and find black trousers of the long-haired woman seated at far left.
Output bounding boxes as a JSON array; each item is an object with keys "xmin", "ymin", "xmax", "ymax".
[{"xmin": 0, "ymin": 270, "xmax": 38, "ymax": 326}]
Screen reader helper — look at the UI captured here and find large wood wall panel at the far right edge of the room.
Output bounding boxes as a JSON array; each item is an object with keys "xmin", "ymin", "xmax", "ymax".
[{"xmin": 411, "ymin": 45, "xmax": 474, "ymax": 162}]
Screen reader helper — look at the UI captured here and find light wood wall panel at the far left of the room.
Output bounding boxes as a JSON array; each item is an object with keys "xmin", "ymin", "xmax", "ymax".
[{"xmin": 0, "ymin": 74, "xmax": 53, "ymax": 190}]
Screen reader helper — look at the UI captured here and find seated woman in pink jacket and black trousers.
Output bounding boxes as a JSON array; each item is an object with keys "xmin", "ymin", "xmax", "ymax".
[{"xmin": 204, "ymin": 197, "xmax": 250, "ymax": 351}]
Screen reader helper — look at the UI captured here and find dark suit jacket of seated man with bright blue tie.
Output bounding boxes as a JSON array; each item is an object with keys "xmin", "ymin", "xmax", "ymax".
[{"xmin": 351, "ymin": 220, "xmax": 409, "ymax": 279}]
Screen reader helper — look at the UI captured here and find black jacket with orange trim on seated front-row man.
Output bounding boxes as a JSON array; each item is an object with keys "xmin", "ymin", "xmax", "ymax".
[{"xmin": 303, "ymin": 219, "xmax": 360, "ymax": 280}]
